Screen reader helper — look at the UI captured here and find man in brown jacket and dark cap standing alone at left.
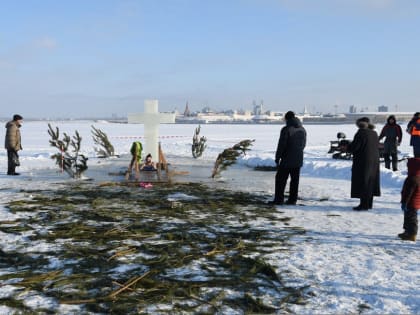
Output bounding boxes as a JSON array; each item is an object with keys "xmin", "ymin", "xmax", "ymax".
[{"xmin": 4, "ymin": 114, "xmax": 23, "ymax": 175}]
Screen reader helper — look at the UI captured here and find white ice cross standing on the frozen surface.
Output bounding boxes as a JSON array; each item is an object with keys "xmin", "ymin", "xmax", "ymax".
[{"xmin": 128, "ymin": 100, "xmax": 175, "ymax": 161}]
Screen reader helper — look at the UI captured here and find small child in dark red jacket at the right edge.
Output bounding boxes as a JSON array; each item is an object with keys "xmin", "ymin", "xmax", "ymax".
[{"xmin": 398, "ymin": 158, "xmax": 420, "ymax": 242}]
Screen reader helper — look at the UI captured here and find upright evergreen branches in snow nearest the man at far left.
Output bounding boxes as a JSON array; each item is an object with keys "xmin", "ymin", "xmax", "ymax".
[{"xmin": 48, "ymin": 124, "xmax": 88, "ymax": 178}]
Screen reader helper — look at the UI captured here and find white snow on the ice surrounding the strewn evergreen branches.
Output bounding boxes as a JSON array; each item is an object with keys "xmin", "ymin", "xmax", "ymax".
[{"xmin": 0, "ymin": 121, "xmax": 420, "ymax": 314}]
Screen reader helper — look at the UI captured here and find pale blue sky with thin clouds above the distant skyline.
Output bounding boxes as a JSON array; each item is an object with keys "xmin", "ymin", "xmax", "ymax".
[{"xmin": 0, "ymin": 0, "xmax": 420, "ymax": 117}]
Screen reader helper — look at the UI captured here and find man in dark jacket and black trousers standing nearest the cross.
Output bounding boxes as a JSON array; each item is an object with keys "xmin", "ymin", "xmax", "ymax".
[{"xmin": 273, "ymin": 111, "xmax": 306, "ymax": 205}]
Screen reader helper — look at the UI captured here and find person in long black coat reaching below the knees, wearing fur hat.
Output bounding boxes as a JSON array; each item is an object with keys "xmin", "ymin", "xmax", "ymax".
[{"xmin": 348, "ymin": 117, "xmax": 381, "ymax": 211}]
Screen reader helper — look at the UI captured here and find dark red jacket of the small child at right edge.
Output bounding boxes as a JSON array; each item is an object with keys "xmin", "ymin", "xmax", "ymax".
[{"xmin": 401, "ymin": 158, "xmax": 420, "ymax": 209}]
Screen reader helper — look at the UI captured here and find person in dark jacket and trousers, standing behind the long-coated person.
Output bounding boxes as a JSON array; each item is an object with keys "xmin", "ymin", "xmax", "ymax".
[{"xmin": 379, "ymin": 115, "xmax": 402, "ymax": 171}]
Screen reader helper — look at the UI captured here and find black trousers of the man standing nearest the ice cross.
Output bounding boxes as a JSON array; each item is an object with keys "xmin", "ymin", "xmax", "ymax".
[{"xmin": 274, "ymin": 166, "xmax": 300, "ymax": 203}]
